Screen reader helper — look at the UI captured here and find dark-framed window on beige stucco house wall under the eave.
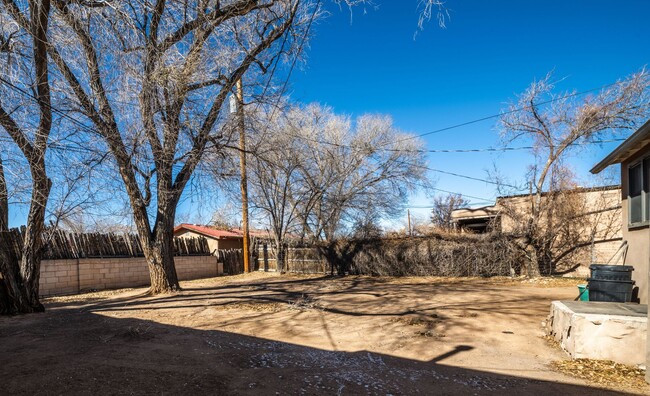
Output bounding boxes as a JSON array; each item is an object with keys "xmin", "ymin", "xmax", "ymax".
[{"xmin": 627, "ymin": 157, "xmax": 650, "ymax": 226}]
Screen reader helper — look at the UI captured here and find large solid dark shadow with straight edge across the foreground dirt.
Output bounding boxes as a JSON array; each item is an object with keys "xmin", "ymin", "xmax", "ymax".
[{"xmin": 0, "ymin": 309, "xmax": 621, "ymax": 396}]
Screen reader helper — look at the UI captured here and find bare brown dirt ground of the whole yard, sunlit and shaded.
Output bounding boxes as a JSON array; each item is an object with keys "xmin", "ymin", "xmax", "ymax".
[{"xmin": 0, "ymin": 273, "xmax": 650, "ymax": 395}]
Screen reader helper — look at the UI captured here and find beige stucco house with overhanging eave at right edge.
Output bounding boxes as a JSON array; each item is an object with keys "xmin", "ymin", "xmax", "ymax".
[{"xmin": 591, "ymin": 120, "xmax": 650, "ymax": 304}]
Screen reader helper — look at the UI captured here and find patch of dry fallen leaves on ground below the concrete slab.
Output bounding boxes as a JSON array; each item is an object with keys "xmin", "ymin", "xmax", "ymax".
[{"xmin": 551, "ymin": 359, "xmax": 650, "ymax": 390}]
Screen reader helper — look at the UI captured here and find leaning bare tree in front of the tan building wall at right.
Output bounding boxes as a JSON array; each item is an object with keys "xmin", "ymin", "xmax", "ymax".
[{"xmin": 500, "ymin": 70, "xmax": 650, "ymax": 276}]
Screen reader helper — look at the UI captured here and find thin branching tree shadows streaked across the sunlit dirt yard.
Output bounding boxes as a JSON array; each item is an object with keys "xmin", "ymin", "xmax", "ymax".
[{"xmin": 60, "ymin": 276, "xmax": 548, "ymax": 342}]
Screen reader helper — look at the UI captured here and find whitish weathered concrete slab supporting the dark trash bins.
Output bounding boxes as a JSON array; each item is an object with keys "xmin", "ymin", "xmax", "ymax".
[{"xmin": 546, "ymin": 301, "xmax": 648, "ymax": 365}]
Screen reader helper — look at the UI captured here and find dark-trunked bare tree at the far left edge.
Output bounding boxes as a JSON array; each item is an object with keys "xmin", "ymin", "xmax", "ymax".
[{"xmin": 0, "ymin": 0, "xmax": 52, "ymax": 313}]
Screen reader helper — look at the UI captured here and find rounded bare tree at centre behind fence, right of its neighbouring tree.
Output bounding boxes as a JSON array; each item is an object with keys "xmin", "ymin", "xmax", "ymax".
[{"xmin": 299, "ymin": 110, "xmax": 428, "ymax": 241}]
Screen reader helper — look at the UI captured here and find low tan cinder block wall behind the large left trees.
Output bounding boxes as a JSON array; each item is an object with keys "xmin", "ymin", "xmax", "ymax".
[{"xmin": 40, "ymin": 256, "xmax": 223, "ymax": 296}]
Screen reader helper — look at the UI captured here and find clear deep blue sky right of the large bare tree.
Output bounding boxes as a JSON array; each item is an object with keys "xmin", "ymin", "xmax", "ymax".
[{"xmin": 290, "ymin": 0, "xmax": 650, "ymax": 223}]
